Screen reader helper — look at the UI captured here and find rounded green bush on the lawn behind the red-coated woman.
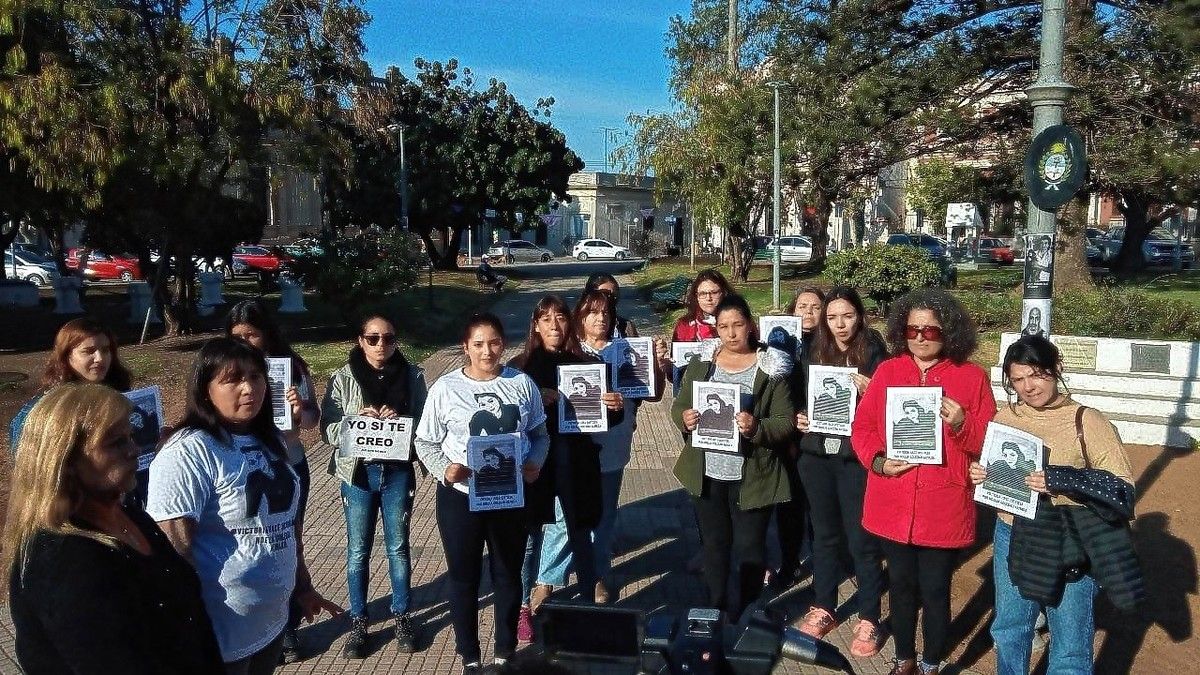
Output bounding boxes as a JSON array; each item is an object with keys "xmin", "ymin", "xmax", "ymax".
[{"xmin": 826, "ymin": 244, "xmax": 942, "ymax": 311}]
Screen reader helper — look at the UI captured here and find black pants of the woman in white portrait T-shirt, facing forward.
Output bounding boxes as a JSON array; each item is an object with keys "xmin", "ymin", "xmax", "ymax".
[{"xmin": 437, "ymin": 484, "xmax": 528, "ymax": 663}]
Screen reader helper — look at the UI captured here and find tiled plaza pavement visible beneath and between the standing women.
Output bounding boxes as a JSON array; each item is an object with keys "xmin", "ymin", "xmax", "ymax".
[{"xmin": 0, "ymin": 270, "xmax": 984, "ymax": 674}]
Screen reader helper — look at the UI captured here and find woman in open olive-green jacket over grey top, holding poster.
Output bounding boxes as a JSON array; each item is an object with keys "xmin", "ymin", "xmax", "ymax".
[{"xmin": 671, "ymin": 295, "xmax": 796, "ymax": 621}]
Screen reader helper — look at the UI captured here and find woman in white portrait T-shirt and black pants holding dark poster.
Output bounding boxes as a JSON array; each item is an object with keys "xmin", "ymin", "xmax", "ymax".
[{"xmin": 414, "ymin": 313, "xmax": 550, "ymax": 675}]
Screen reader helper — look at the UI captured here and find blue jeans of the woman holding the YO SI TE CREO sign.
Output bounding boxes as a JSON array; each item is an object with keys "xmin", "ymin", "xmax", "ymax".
[{"xmin": 342, "ymin": 462, "xmax": 415, "ymax": 616}]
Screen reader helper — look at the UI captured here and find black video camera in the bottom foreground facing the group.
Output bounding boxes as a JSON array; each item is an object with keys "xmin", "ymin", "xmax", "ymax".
[{"xmin": 538, "ymin": 602, "xmax": 853, "ymax": 675}]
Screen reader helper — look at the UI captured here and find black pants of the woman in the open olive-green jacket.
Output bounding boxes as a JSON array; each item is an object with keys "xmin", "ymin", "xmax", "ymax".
[{"xmin": 692, "ymin": 478, "xmax": 773, "ymax": 621}]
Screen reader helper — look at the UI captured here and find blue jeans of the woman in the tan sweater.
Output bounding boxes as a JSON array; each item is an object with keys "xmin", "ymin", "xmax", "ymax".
[{"xmin": 991, "ymin": 518, "xmax": 1096, "ymax": 675}]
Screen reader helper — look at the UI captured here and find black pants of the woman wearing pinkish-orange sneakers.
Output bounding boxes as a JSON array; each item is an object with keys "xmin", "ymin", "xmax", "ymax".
[{"xmin": 799, "ymin": 453, "xmax": 883, "ymax": 623}]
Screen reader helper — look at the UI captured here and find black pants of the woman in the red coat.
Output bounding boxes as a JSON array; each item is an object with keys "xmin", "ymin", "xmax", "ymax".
[{"xmin": 880, "ymin": 539, "xmax": 959, "ymax": 664}]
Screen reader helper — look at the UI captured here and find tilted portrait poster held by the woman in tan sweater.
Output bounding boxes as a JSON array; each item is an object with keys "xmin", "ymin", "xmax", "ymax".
[{"xmin": 974, "ymin": 422, "xmax": 1045, "ymax": 520}]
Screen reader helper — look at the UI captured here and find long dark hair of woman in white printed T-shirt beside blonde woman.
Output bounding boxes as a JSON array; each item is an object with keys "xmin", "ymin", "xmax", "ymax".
[{"xmin": 176, "ymin": 338, "xmax": 286, "ymax": 458}]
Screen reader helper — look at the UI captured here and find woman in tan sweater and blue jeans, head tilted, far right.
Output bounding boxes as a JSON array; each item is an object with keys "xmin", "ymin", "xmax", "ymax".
[{"xmin": 971, "ymin": 336, "xmax": 1133, "ymax": 675}]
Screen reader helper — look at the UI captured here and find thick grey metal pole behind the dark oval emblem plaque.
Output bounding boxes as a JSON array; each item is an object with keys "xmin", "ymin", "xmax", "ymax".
[{"xmin": 1021, "ymin": 0, "xmax": 1074, "ymax": 335}]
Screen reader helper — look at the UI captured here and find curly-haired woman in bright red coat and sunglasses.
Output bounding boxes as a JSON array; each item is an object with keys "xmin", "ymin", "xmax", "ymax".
[{"xmin": 851, "ymin": 288, "xmax": 996, "ymax": 675}]
